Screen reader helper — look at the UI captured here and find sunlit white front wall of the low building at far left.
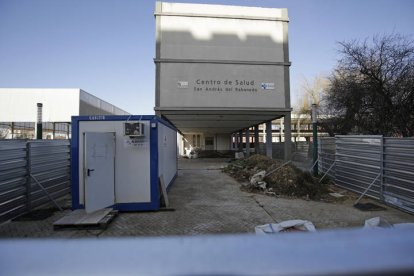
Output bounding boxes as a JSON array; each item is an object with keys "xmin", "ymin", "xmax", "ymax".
[{"xmin": 0, "ymin": 88, "xmax": 80, "ymax": 122}]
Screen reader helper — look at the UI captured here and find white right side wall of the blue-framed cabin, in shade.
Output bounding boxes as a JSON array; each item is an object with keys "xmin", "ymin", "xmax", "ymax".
[{"xmin": 158, "ymin": 123, "xmax": 177, "ymax": 186}]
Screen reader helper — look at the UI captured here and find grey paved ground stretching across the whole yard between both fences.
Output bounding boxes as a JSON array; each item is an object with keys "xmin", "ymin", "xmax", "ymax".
[{"xmin": 0, "ymin": 159, "xmax": 414, "ymax": 238}]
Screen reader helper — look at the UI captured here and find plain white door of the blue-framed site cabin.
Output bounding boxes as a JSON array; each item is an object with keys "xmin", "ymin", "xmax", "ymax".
[{"xmin": 84, "ymin": 132, "xmax": 115, "ymax": 213}]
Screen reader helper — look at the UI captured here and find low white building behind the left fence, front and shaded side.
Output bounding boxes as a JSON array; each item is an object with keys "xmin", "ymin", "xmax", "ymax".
[{"xmin": 0, "ymin": 88, "xmax": 129, "ymax": 139}]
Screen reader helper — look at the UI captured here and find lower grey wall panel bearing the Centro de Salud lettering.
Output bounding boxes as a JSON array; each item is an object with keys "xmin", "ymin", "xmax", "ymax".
[{"xmin": 160, "ymin": 63, "xmax": 285, "ymax": 108}]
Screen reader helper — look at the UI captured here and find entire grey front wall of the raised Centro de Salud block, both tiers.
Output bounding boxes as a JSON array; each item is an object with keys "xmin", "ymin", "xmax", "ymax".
[{"xmin": 155, "ymin": 3, "xmax": 290, "ymax": 109}]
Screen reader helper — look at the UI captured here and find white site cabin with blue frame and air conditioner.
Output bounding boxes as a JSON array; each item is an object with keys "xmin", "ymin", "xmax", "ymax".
[{"xmin": 71, "ymin": 115, "xmax": 177, "ymax": 213}]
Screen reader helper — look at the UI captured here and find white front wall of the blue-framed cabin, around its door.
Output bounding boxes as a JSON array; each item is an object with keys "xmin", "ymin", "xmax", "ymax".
[{"xmin": 79, "ymin": 121, "xmax": 152, "ymax": 204}]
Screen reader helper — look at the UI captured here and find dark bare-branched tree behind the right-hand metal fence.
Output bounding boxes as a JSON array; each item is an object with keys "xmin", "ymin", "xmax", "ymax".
[{"xmin": 326, "ymin": 34, "xmax": 414, "ymax": 136}]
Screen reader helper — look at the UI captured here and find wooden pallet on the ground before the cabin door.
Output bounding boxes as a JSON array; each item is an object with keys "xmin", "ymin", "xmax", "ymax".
[{"xmin": 53, "ymin": 208, "xmax": 118, "ymax": 230}]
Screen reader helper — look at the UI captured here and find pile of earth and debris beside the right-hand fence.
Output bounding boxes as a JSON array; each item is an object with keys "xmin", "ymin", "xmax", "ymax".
[{"xmin": 223, "ymin": 155, "xmax": 330, "ymax": 200}]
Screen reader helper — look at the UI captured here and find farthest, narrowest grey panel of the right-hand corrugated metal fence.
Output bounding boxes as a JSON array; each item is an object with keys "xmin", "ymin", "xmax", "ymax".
[{"xmin": 318, "ymin": 137, "xmax": 336, "ymax": 180}]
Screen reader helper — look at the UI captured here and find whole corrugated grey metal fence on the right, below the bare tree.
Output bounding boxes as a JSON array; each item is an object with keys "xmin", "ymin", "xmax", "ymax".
[{"xmin": 318, "ymin": 135, "xmax": 414, "ymax": 213}]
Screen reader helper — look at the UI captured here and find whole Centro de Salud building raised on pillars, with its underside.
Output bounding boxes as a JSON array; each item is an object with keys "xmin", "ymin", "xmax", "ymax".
[{"xmin": 154, "ymin": 2, "xmax": 291, "ymax": 159}]
